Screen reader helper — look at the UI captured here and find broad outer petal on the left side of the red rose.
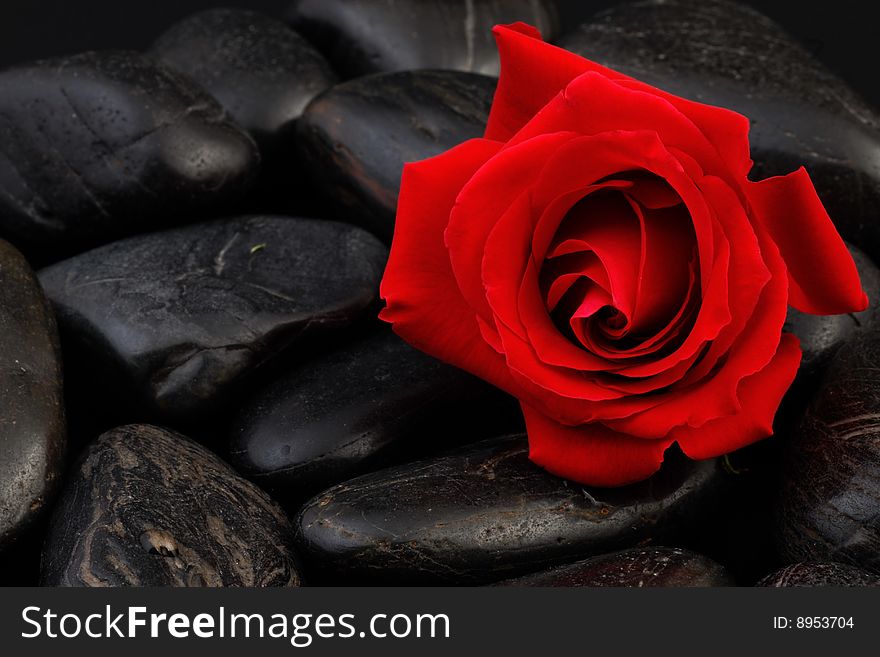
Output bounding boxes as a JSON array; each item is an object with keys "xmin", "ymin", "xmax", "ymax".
[{"xmin": 379, "ymin": 139, "xmax": 518, "ymax": 395}]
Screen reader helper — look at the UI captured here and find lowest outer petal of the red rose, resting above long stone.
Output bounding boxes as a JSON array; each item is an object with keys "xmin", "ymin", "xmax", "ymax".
[{"xmin": 522, "ymin": 404, "xmax": 672, "ymax": 486}]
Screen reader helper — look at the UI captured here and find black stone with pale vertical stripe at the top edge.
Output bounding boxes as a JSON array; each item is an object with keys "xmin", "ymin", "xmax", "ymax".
[{"xmin": 288, "ymin": 0, "xmax": 558, "ymax": 77}]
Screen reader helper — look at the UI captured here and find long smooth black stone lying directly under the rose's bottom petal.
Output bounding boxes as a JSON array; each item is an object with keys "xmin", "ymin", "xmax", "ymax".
[{"xmin": 296, "ymin": 436, "xmax": 722, "ymax": 584}]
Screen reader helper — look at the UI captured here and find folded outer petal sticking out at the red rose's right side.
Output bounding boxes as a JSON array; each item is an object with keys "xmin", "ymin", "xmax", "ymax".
[{"xmin": 748, "ymin": 167, "xmax": 868, "ymax": 315}]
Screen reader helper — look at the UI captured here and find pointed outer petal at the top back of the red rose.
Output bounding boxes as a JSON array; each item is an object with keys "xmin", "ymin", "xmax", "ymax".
[{"xmin": 485, "ymin": 23, "xmax": 752, "ymax": 176}]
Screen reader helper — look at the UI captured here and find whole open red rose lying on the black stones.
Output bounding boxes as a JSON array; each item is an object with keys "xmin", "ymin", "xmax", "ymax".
[{"xmin": 381, "ymin": 24, "xmax": 867, "ymax": 486}]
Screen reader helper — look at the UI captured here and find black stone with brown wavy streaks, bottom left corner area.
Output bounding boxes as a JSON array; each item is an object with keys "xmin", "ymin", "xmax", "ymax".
[{"xmin": 42, "ymin": 425, "xmax": 300, "ymax": 586}]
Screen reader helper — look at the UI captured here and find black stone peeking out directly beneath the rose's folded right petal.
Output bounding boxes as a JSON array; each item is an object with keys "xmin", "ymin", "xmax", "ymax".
[{"xmin": 783, "ymin": 245, "xmax": 880, "ymax": 378}]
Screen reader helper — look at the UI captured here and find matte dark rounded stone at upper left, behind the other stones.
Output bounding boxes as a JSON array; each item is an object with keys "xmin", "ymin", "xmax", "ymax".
[{"xmin": 150, "ymin": 8, "xmax": 335, "ymax": 154}]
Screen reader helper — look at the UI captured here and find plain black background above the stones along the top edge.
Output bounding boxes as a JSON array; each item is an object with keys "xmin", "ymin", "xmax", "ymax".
[{"xmin": 0, "ymin": 0, "xmax": 880, "ymax": 106}]
